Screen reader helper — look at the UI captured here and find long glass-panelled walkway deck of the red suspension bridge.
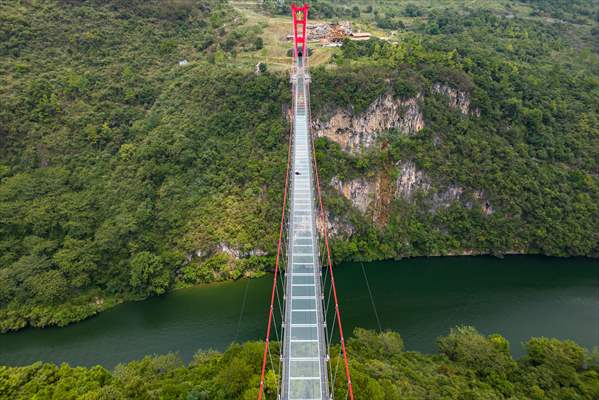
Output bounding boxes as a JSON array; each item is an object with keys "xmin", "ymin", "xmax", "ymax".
[{"xmin": 281, "ymin": 57, "xmax": 329, "ymax": 400}]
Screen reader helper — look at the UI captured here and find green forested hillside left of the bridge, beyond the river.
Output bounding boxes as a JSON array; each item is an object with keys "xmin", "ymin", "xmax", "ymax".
[{"xmin": 0, "ymin": 1, "xmax": 289, "ymax": 330}]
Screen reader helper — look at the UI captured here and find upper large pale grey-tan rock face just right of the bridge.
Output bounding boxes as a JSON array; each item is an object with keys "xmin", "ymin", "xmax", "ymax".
[{"xmin": 312, "ymin": 95, "xmax": 424, "ymax": 153}]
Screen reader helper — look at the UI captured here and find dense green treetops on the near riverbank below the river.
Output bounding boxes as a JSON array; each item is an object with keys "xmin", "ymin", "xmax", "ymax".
[{"xmin": 0, "ymin": 327, "xmax": 599, "ymax": 400}]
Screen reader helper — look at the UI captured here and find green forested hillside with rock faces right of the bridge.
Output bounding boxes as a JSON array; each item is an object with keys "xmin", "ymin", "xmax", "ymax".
[{"xmin": 313, "ymin": 11, "xmax": 599, "ymax": 260}]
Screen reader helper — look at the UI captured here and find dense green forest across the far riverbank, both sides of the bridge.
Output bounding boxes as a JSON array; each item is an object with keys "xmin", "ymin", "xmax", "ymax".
[{"xmin": 0, "ymin": 0, "xmax": 599, "ymax": 332}]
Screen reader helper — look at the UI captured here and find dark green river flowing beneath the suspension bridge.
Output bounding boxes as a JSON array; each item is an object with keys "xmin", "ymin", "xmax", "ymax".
[{"xmin": 0, "ymin": 256, "xmax": 599, "ymax": 367}]
